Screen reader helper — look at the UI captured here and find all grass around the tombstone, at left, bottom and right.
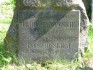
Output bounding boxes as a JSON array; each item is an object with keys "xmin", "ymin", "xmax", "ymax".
[{"xmin": 0, "ymin": 0, "xmax": 93, "ymax": 70}]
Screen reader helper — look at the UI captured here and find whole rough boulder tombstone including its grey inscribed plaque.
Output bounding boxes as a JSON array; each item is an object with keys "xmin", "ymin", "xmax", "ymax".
[{"xmin": 5, "ymin": 0, "xmax": 88, "ymax": 62}]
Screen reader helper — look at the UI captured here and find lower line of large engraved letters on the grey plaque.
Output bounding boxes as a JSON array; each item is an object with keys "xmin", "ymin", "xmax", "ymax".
[{"xmin": 27, "ymin": 43, "xmax": 71, "ymax": 50}]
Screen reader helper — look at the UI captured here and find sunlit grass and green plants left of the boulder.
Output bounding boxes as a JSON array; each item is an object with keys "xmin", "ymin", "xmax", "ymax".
[{"xmin": 0, "ymin": 0, "xmax": 14, "ymax": 67}]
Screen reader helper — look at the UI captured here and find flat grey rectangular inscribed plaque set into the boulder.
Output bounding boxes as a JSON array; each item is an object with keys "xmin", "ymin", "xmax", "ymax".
[{"xmin": 18, "ymin": 10, "xmax": 80, "ymax": 62}]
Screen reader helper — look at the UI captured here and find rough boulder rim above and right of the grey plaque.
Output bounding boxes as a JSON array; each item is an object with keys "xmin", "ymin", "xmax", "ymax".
[{"xmin": 17, "ymin": 0, "xmax": 89, "ymax": 49}]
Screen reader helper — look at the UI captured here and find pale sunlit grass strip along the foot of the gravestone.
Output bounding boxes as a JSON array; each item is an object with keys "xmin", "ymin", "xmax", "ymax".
[{"xmin": 1, "ymin": 61, "xmax": 83, "ymax": 70}]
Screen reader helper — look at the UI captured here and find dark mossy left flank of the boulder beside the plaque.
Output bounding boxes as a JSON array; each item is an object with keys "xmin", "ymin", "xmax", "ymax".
[{"xmin": 4, "ymin": 11, "xmax": 18, "ymax": 53}]
